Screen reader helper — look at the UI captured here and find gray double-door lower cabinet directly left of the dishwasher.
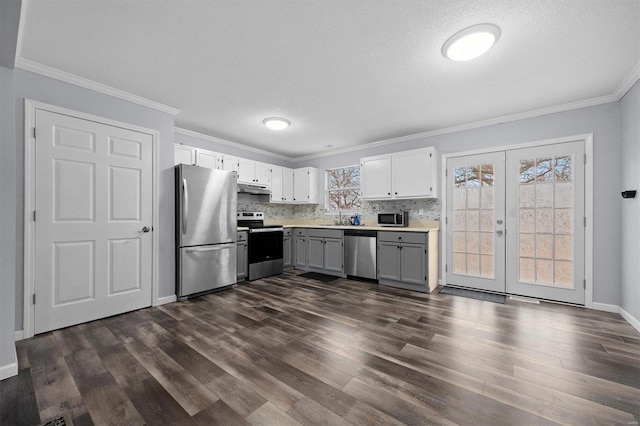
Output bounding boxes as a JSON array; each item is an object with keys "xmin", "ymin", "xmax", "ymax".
[{"xmin": 307, "ymin": 228, "xmax": 344, "ymax": 276}]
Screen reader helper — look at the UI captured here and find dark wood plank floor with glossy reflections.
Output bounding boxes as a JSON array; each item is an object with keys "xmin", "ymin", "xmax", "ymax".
[{"xmin": 0, "ymin": 272, "xmax": 640, "ymax": 426}]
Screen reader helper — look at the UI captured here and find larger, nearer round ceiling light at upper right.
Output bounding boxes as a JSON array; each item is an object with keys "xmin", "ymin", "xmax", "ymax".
[{"xmin": 442, "ymin": 24, "xmax": 500, "ymax": 61}]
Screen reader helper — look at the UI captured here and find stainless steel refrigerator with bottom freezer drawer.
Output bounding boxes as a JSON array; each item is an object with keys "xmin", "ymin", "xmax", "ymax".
[{"xmin": 175, "ymin": 164, "xmax": 238, "ymax": 300}]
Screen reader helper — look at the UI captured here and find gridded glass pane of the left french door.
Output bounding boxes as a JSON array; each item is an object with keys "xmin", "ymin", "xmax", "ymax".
[{"xmin": 453, "ymin": 164, "xmax": 495, "ymax": 278}]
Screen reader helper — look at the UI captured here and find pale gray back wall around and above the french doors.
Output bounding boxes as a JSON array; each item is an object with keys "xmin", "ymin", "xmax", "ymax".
[{"xmin": 296, "ymin": 102, "xmax": 620, "ymax": 305}]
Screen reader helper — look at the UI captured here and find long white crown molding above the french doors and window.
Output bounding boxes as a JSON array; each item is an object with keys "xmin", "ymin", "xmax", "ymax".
[{"xmin": 291, "ymin": 92, "xmax": 620, "ymax": 163}]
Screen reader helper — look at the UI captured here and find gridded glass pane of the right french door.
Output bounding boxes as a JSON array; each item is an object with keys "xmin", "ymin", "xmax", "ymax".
[{"xmin": 518, "ymin": 156, "xmax": 574, "ymax": 288}]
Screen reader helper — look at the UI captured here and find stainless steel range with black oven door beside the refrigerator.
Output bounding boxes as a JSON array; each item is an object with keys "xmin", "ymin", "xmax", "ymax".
[{"xmin": 238, "ymin": 212, "xmax": 283, "ymax": 281}]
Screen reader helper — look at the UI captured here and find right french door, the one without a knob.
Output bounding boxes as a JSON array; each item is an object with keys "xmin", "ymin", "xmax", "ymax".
[{"xmin": 507, "ymin": 142, "xmax": 585, "ymax": 304}]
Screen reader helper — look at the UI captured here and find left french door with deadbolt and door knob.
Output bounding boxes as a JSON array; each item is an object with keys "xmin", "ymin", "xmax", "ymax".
[{"xmin": 447, "ymin": 151, "xmax": 505, "ymax": 292}]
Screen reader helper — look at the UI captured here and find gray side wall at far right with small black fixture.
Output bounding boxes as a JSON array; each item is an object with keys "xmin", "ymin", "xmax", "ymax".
[{"xmin": 618, "ymin": 82, "xmax": 640, "ymax": 322}]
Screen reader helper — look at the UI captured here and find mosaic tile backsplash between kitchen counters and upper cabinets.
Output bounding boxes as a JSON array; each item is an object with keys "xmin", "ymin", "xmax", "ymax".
[{"xmin": 238, "ymin": 193, "xmax": 440, "ymax": 224}]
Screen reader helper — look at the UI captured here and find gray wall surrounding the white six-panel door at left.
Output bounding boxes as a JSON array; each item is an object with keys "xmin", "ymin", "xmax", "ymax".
[{"xmin": 14, "ymin": 69, "xmax": 175, "ymax": 330}]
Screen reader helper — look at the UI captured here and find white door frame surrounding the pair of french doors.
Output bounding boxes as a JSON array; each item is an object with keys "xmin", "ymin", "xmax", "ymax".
[{"xmin": 440, "ymin": 133, "xmax": 593, "ymax": 309}]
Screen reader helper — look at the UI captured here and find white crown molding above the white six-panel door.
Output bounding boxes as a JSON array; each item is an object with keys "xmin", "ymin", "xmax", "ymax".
[{"xmin": 15, "ymin": 57, "xmax": 180, "ymax": 116}]
